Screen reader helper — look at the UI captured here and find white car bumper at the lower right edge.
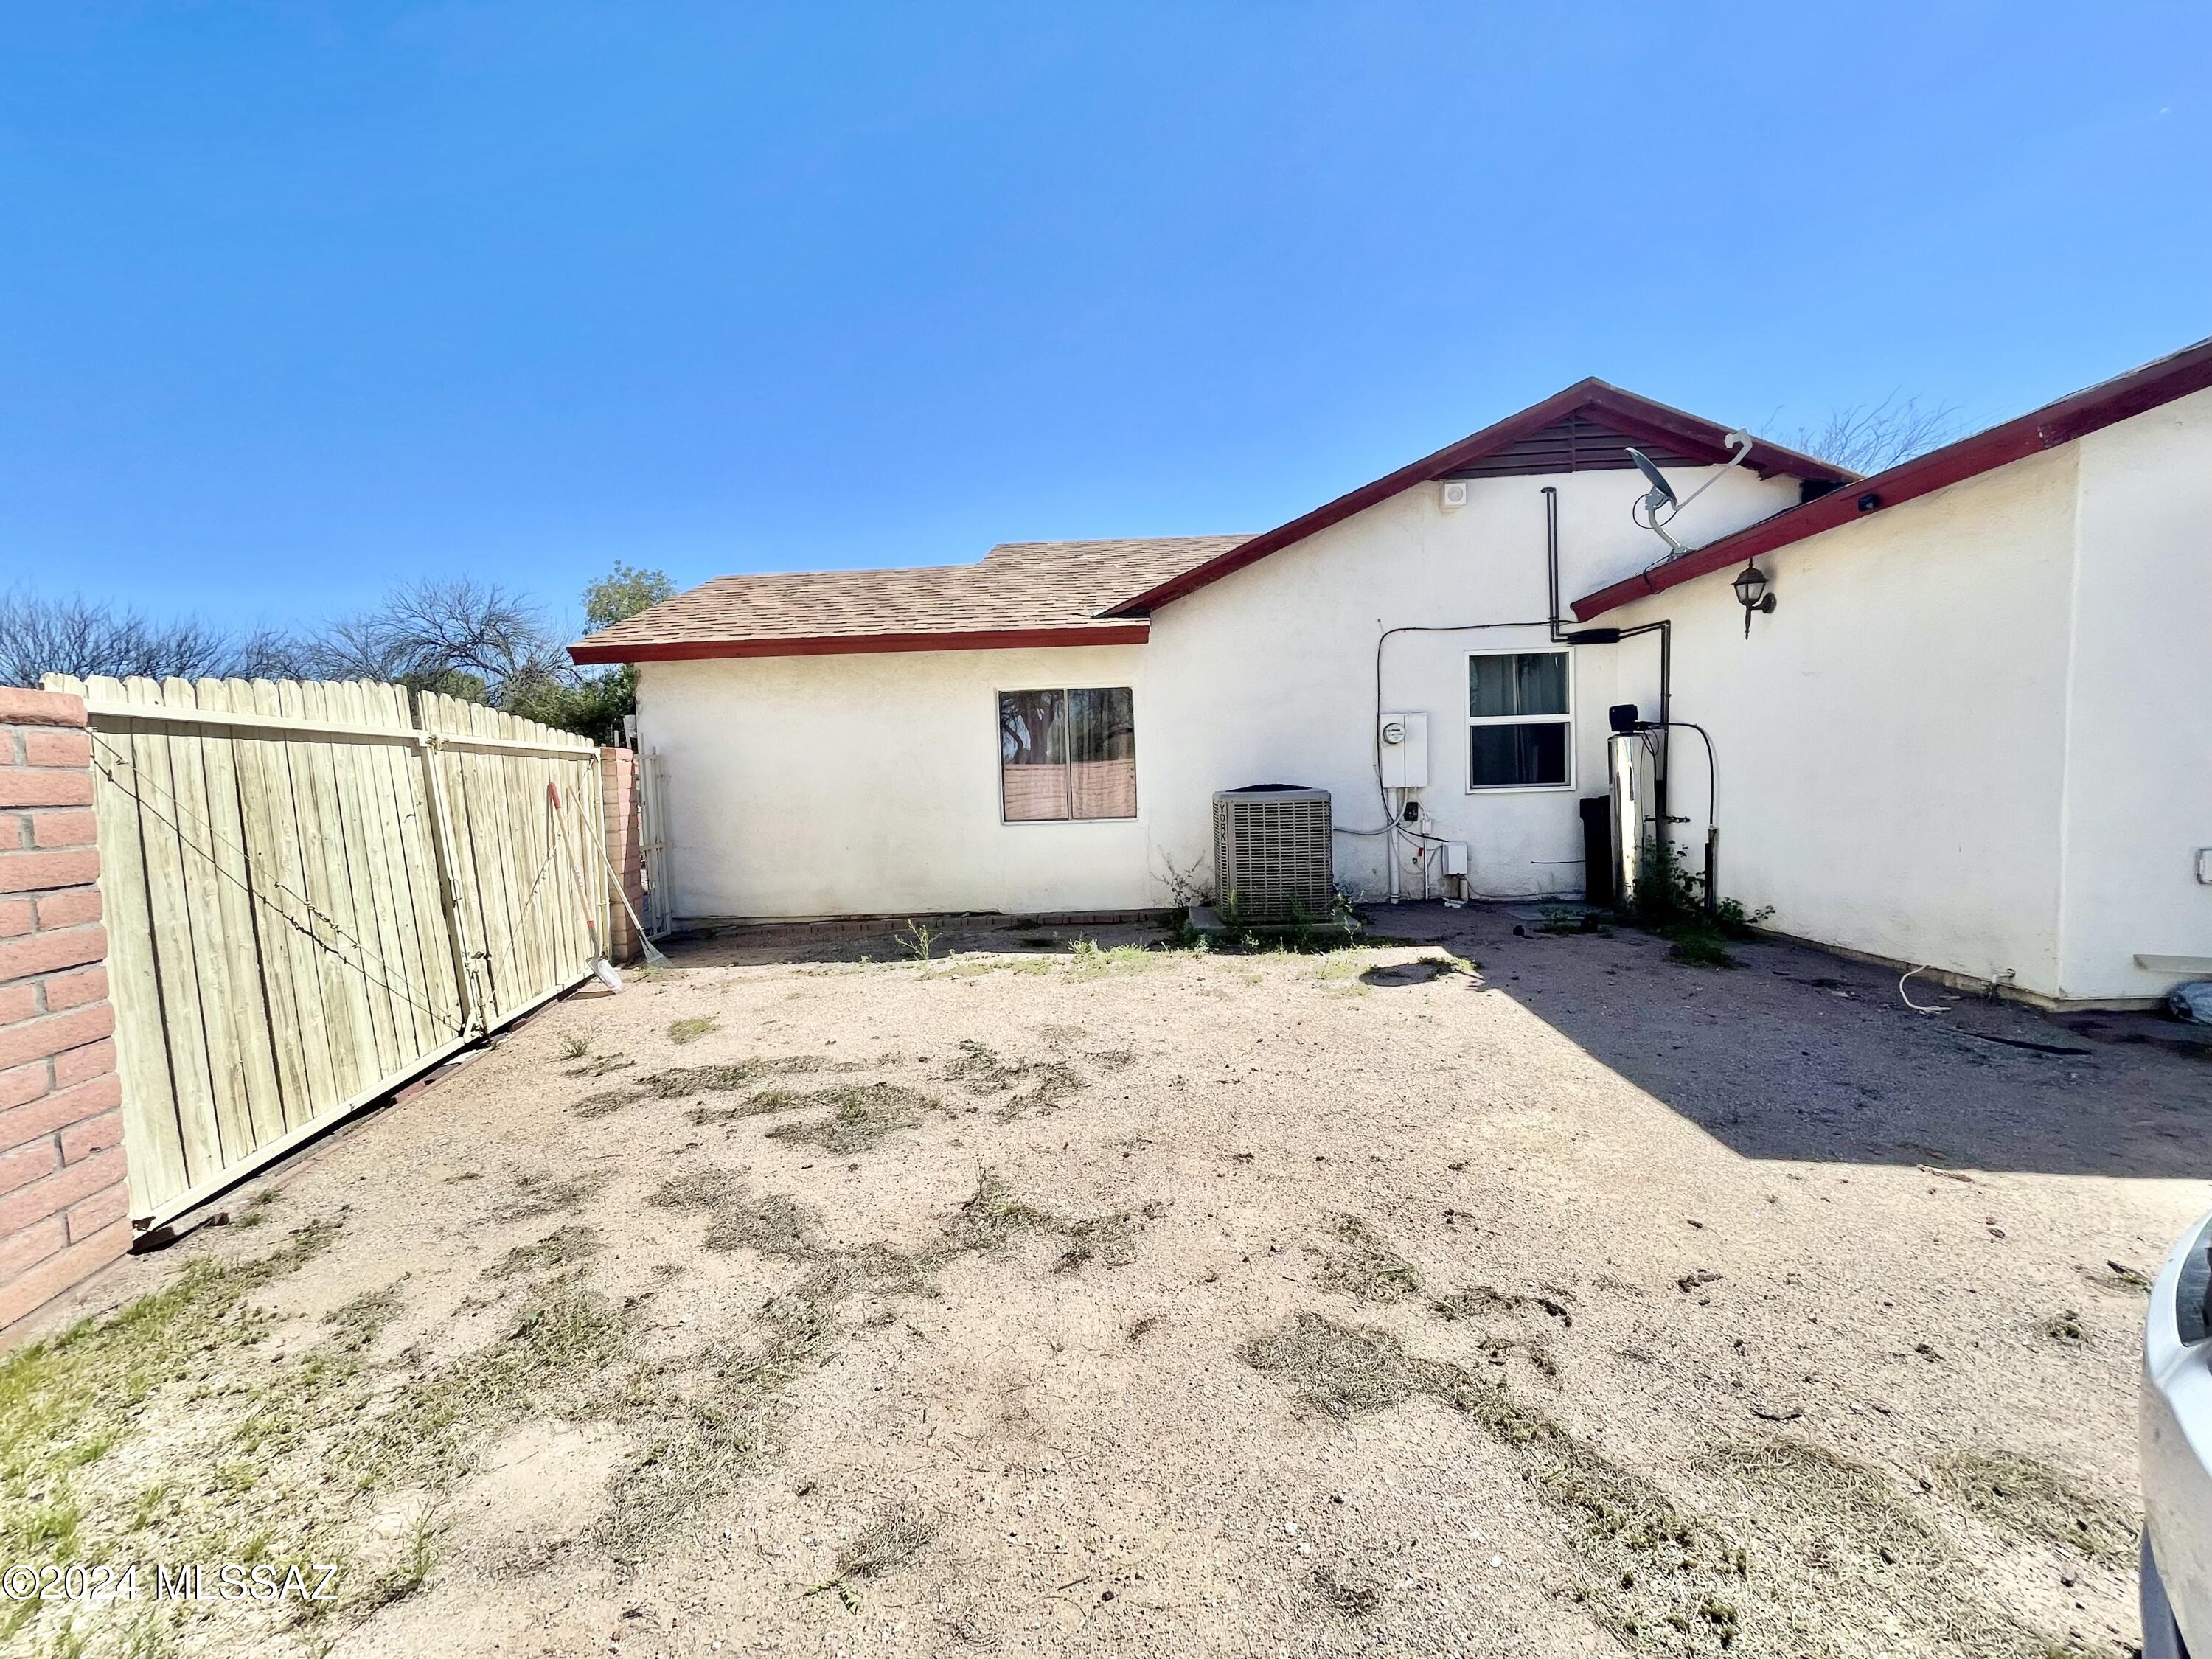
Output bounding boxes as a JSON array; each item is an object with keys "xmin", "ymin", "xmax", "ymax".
[{"xmin": 2143, "ymin": 1217, "xmax": 2212, "ymax": 1659}]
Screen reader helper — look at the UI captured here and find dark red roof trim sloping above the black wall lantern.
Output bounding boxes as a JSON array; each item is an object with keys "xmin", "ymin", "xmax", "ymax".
[{"xmin": 1573, "ymin": 341, "xmax": 2212, "ymax": 622}]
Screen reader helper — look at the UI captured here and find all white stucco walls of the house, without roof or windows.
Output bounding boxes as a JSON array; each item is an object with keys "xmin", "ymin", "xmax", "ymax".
[{"xmin": 639, "ymin": 392, "xmax": 2212, "ymax": 1000}]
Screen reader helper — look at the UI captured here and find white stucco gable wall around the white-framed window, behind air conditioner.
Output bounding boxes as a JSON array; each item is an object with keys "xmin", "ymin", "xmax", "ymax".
[{"xmin": 1146, "ymin": 471, "xmax": 1796, "ymax": 898}]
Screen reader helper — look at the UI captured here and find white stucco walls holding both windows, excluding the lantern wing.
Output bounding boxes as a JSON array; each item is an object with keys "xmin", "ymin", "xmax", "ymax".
[{"xmin": 639, "ymin": 469, "xmax": 1796, "ymax": 918}]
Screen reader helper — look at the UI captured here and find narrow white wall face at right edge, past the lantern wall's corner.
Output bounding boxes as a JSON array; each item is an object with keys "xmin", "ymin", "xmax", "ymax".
[{"xmin": 2059, "ymin": 392, "xmax": 2212, "ymax": 998}]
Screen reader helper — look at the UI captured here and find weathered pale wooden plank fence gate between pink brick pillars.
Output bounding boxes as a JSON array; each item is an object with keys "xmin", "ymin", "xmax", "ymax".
[{"xmin": 46, "ymin": 675, "xmax": 606, "ymax": 1225}]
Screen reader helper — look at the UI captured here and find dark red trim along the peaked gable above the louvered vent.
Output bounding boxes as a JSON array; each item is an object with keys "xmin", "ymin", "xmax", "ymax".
[{"xmin": 1108, "ymin": 380, "xmax": 1856, "ymax": 617}]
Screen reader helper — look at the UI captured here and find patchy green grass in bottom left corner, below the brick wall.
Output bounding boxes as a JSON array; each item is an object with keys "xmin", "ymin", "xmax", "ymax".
[{"xmin": 0, "ymin": 1225, "xmax": 526, "ymax": 1655}]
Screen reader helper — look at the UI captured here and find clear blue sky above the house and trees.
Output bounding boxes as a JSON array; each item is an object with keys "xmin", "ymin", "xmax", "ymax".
[{"xmin": 0, "ymin": 0, "xmax": 2212, "ymax": 622}]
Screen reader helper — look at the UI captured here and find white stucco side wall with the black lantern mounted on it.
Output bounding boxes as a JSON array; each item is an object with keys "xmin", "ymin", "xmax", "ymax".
[{"xmin": 1601, "ymin": 445, "xmax": 2079, "ymax": 995}]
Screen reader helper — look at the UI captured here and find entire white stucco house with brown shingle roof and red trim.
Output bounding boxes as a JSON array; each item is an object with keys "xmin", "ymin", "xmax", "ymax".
[{"xmin": 573, "ymin": 341, "xmax": 2212, "ymax": 1004}]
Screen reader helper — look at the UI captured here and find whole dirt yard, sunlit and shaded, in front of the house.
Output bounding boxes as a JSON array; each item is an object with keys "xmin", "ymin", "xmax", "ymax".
[{"xmin": 0, "ymin": 907, "xmax": 2212, "ymax": 1659}]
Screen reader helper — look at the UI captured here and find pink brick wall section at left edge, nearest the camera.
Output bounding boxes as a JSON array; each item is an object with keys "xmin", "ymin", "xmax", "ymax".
[{"xmin": 0, "ymin": 688, "xmax": 131, "ymax": 1329}]
